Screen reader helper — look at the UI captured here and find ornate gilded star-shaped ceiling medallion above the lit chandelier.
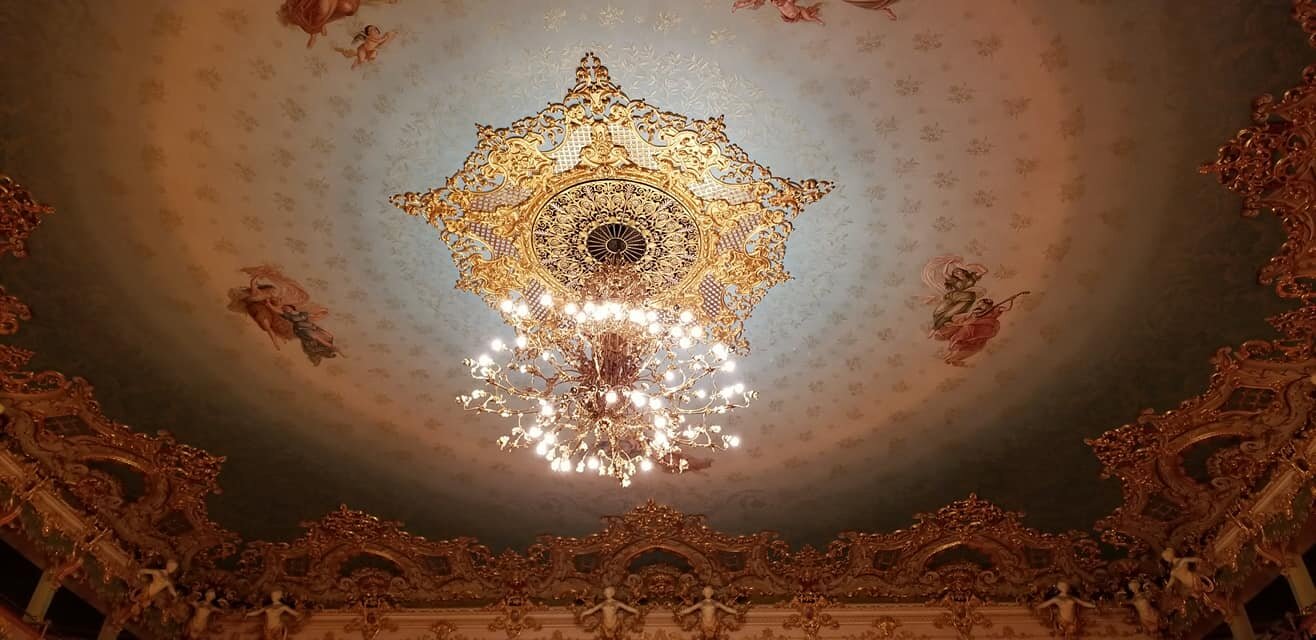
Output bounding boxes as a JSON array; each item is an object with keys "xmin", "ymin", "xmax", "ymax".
[{"xmin": 392, "ymin": 53, "xmax": 832, "ymax": 350}]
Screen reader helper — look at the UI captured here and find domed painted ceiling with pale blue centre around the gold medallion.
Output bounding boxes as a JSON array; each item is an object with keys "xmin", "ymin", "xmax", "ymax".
[{"xmin": 0, "ymin": 0, "xmax": 1309, "ymax": 545}]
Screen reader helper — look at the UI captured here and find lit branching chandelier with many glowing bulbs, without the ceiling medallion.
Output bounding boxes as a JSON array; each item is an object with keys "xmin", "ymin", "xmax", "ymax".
[{"xmin": 458, "ymin": 295, "xmax": 757, "ymax": 486}]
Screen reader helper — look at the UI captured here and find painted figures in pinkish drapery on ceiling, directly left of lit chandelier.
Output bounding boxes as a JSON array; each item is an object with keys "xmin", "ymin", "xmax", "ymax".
[{"xmin": 229, "ymin": 265, "xmax": 342, "ymax": 366}]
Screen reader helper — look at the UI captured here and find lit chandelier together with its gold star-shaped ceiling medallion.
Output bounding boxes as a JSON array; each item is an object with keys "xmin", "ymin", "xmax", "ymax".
[{"xmin": 392, "ymin": 54, "xmax": 832, "ymax": 486}]
